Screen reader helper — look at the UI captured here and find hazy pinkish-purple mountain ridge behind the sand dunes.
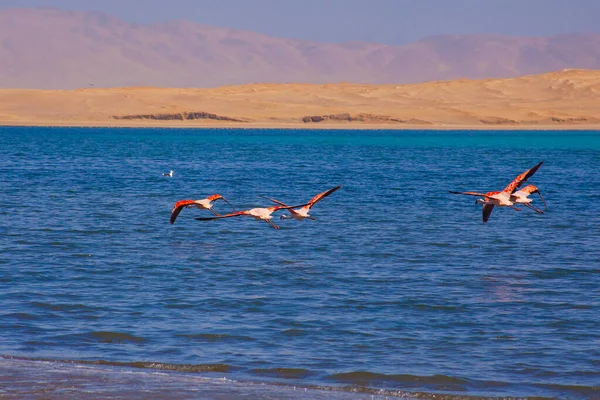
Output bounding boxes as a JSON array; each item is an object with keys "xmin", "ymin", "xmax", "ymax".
[{"xmin": 0, "ymin": 8, "xmax": 600, "ymax": 89}]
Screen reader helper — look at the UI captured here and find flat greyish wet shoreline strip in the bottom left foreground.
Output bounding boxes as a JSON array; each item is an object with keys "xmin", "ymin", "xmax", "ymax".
[{"xmin": 0, "ymin": 357, "xmax": 398, "ymax": 400}]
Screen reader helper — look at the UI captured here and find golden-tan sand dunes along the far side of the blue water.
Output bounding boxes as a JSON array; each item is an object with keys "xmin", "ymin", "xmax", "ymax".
[{"xmin": 0, "ymin": 70, "xmax": 600, "ymax": 129}]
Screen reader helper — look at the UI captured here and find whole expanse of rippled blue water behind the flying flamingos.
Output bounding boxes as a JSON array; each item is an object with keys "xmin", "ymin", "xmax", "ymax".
[{"xmin": 0, "ymin": 127, "xmax": 600, "ymax": 399}]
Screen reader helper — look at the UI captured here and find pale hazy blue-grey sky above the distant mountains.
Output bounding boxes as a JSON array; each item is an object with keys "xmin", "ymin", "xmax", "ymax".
[{"xmin": 0, "ymin": 0, "xmax": 600, "ymax": 44}]
